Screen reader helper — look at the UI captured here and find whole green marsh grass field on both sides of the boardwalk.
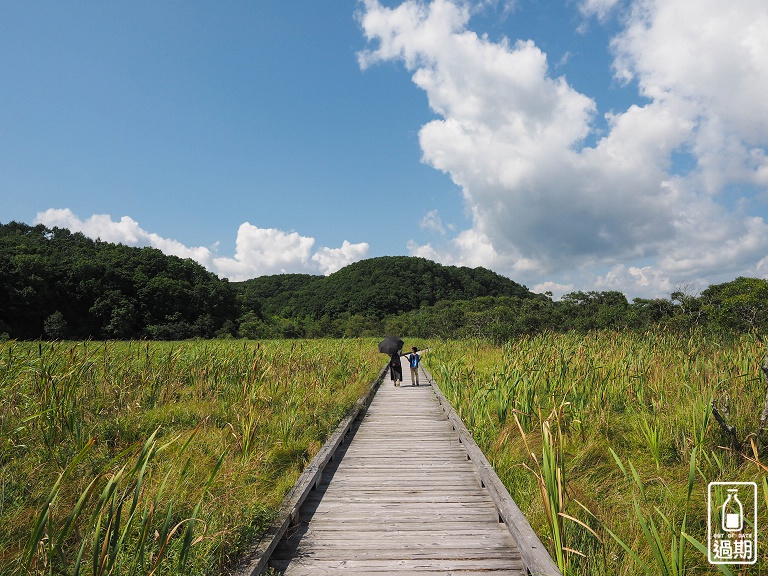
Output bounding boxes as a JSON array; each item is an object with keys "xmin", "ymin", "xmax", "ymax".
[{"xmin": 0, "ymin": 332, "xmax": 768, "ymax": 576}]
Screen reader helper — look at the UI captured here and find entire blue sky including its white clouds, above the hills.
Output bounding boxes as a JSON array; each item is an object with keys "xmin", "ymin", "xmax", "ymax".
[{"xmin": 0, "ymin": 0, "xmax": 768, "ymax": 297}]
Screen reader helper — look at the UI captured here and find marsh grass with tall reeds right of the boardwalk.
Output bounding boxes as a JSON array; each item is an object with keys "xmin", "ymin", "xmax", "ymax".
[{"xmin": 425, "ymin": 332, "xmax": 768, "ymax": 576}]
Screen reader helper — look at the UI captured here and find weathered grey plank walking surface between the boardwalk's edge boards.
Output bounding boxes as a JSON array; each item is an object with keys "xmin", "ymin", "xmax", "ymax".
[{"xmin": 270, "ymin": 358, "xmax": 526, "ymax": 576}]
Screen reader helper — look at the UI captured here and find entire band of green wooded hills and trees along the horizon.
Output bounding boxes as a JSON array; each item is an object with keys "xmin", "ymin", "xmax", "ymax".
[{"xmin": 0, "ymin": 222, "xmax": 768, "ymax": 341}]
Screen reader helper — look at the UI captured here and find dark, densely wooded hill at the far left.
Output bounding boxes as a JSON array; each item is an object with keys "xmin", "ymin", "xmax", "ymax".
[{"xmin": 0, "ymin": 222, "xmax": 238, "ymax": 339}]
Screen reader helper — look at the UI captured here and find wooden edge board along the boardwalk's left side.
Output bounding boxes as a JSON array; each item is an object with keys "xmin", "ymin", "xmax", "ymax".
[{"xmin": 233, "ymin": 366, "xmax": 387, "ymax": 576}]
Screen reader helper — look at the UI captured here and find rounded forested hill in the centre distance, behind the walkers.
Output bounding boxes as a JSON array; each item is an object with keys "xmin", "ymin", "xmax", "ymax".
[{"xmin": 233, "ymin": 256, "xmax": 542, "ymax": 320}]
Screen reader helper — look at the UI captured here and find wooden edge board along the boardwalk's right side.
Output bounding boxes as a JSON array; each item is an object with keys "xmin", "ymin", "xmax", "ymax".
[{"xmin": 424, "ymin": 370, "xmax": 562, "ymax": 576}]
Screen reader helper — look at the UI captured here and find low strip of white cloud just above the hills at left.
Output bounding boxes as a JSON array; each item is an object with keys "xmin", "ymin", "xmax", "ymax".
[{"xmin": 36, "ymin": 208, "xmax": 368, "ymax": 281}]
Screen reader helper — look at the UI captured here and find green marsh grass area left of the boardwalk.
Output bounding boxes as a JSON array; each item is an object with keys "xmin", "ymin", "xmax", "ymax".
[{"xmin": 0, "ymin": 340, "xmax": 383, "ymax": 576}]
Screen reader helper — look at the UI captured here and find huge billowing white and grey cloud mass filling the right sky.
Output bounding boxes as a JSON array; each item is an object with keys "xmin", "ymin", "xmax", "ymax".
[{"xmin": 359, "ymin": 0, "xmax": 768, "ymax": 295}]
